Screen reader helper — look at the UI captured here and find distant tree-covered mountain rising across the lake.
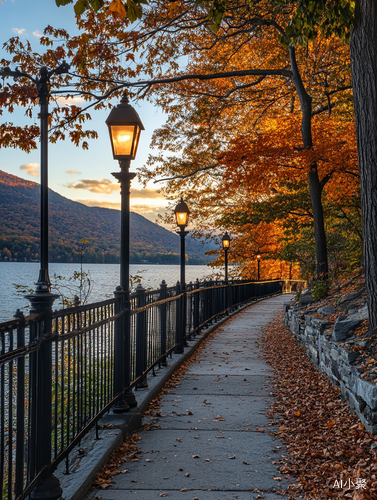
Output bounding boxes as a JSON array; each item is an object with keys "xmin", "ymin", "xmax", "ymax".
[{"xmin": 0, "ymin": 170, "xmax": 210, "ymax": 264}]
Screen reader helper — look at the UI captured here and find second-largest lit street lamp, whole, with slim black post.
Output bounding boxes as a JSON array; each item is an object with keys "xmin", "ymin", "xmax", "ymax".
[{"xmin": 174, "ymin": 198, "xmax": 190, "ymax": 354}]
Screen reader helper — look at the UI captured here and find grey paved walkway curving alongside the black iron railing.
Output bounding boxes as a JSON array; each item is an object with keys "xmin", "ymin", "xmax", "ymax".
[{"xmin": 86, "ymin": 295, "xmax": 291, "ymax": 500}]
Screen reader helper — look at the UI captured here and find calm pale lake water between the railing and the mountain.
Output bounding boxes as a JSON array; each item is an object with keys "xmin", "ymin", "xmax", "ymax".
[{"xmin": 0, "ymin": 262, "xmax": 217, "ymax": 322}]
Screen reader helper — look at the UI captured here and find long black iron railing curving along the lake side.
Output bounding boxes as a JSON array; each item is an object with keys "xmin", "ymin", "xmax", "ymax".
[{"xmin": 0, "ymin": 281, "xmax": 282, "ymax": 500}]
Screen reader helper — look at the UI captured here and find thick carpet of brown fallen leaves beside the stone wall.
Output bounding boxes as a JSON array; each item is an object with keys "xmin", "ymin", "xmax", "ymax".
[{"xmin": 263, "ymin": 317, "xmax": 377, "ymax": 500}]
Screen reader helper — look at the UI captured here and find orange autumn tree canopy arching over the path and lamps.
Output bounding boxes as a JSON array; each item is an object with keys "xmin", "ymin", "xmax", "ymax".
[{"xmin": 0, "ymin": 0, "xmax": 361, "ymax": 277}]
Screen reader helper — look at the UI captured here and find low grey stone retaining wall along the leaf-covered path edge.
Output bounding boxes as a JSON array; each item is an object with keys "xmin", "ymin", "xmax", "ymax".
[{"xmin": 284, "ymin": 303, "xmax": 377, "ymax": 434}]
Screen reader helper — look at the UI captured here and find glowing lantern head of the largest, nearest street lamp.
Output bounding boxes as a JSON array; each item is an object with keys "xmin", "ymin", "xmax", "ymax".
[{"xmin": 106, "ymin": 92, "xmax": 144, "ymax": 160}]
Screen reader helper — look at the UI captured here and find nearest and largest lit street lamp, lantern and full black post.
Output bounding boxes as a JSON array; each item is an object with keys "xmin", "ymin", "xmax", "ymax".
[{"xmin": 106, "ymin": 93, "xmax": 144, "ymax": 413}]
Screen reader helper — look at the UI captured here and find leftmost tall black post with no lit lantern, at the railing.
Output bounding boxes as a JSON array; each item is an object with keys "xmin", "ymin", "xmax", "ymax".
[{"xmin": 0, "ymin": 62, "xmax": 69, "ymax": 500}]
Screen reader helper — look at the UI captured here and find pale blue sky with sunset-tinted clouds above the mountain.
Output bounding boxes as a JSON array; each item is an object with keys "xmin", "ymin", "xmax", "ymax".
[{"xmin": 0, "ymin": 0, "xmax": 167, "ymax": 221}]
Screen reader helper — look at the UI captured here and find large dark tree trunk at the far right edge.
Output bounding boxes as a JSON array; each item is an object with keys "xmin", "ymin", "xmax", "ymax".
[{"xmin": 350, "ymin": 0, "xmax": 377, "ymax": 331}]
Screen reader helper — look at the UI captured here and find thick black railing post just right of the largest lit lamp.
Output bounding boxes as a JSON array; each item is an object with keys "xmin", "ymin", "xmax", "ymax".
[{"xmin": 136, "ymin": 283, "xmax": 148, "ymax": 389}]
